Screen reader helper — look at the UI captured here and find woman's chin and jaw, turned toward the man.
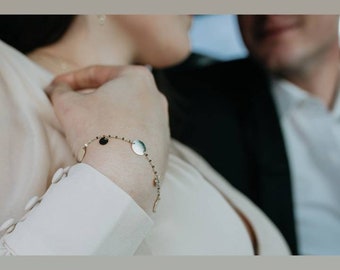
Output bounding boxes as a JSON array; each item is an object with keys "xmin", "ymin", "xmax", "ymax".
[{"xmin": 111, "ymin": 15, "xmax": 191, "ymax": 67}]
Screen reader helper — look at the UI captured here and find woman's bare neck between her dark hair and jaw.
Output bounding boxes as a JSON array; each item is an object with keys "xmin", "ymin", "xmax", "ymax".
[{"xmin": 28, "ymin": 15, "xmax": 135, "ymax": 75}]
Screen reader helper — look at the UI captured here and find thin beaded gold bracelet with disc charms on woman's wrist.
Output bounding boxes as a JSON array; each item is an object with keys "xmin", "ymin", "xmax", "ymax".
[{"xmin": 77, "ymin": 135, "xmax": 161, "ymax": 212}]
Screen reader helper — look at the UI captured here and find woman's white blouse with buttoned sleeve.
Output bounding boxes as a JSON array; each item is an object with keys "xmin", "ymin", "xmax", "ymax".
[{"xmin": 0, "ymin": 42, "xmax": 288, "ymax": 255}]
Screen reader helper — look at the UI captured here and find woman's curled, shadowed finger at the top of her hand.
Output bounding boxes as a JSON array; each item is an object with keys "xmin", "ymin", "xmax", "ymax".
[{"xmin": 52, "ymin": 66, "xmax": 123, "ymax": 90}]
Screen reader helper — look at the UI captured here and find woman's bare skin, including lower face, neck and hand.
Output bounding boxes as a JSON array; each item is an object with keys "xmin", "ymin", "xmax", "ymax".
[{"xmin": 29, "ymin": 15, "xmax": 191, "ymax": 214}]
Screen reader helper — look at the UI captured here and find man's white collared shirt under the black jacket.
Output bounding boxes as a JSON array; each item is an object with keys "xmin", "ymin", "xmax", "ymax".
[{"xmin": 273, "ymin": 80, "xmax": 340, "ymax": 255}]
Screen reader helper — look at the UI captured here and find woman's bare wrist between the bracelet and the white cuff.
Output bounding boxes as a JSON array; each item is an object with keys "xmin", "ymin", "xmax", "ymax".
[{"xmin": 82, "ymin": 136, "xmax": 160, "ymax": 211}]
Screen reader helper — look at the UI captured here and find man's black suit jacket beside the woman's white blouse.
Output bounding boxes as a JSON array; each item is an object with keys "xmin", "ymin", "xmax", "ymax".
[{"xmin": 154, "ymin": 55, "xmax": 297, "ymax": 254}]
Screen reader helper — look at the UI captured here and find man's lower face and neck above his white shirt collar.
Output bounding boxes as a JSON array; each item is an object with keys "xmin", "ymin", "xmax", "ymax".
[{"xmin": 238, "ymin": 15, "xmax": 339, "ymax": 108}]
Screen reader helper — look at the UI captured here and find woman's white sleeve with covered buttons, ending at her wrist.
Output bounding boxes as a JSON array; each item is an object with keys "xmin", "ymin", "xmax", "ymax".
[{"xmin": 0, "ymin": 164, "xmax": 153, "ymax": 255}]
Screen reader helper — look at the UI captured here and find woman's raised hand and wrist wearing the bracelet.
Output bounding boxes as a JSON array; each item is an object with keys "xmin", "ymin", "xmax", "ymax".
[{"xmin": 47, "ymin": 66, "xmax": 170, "ymax": 213}]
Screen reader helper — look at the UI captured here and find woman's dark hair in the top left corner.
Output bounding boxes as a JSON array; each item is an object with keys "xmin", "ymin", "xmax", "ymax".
[{"xmin": 0, "ymin": 15, "xmax": 75, "ymax": 53}]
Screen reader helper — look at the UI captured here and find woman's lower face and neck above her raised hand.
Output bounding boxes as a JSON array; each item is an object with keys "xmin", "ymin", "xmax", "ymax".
[{"xmin": 29, "ymin": 15, "xmax": 191, "ymax": 74}]
